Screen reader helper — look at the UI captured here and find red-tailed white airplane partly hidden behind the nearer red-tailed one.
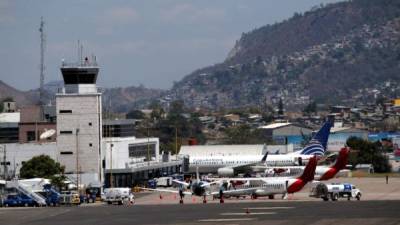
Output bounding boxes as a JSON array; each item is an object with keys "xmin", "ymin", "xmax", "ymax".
[{"xmin": 265, "ymin": 148, "xmax": 350, "ymax": 181}]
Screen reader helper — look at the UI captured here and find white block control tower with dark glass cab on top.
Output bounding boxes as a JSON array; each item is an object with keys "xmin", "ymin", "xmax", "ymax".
[{"xmin": 56, "ymin": 57, "xmax": 103, "ymax": 185}]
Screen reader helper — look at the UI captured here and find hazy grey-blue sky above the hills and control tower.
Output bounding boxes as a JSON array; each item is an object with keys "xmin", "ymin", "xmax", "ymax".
[{"xmin": 0, "ymin": 0, "xmax": 339, "ymax": 90}]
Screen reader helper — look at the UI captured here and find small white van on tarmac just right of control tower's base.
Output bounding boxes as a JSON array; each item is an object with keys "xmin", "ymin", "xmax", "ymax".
[{"xmin": 104, "ymin": 188, "xmax": 135, "ymax": 205}]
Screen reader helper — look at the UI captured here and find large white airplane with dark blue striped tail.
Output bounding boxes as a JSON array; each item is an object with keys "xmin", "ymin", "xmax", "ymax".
[{"xmin": 189, "ymin": 119, "xmax": 333, "ymax": 177}]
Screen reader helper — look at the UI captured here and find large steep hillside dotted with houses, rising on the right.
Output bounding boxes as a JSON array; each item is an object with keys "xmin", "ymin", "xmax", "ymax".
[{"xmin": 171, "ymin": 0, "xmax": 400, "ymax": 110}]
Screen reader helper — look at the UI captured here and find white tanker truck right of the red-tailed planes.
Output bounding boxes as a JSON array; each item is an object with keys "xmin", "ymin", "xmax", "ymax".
[{"xmin": 310, "ymin": 182, "xmax": 362, "ymax": 201}]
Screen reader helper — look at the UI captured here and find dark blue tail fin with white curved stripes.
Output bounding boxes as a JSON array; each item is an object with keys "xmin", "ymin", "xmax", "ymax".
[{"xmin": 300, "ymin": 117, "xmax": 334, "ymax": 156}]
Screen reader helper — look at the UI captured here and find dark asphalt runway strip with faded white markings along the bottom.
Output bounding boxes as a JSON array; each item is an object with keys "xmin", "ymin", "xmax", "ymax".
[{"xmin": 0, "ymin": 201, "xmax": 400, "ymax": 225}]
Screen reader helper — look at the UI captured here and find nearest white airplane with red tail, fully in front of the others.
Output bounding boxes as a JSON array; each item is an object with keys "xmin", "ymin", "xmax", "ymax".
[{"xmin": 211, "ymin": 156, "xmax": 317, "ymax": 203}]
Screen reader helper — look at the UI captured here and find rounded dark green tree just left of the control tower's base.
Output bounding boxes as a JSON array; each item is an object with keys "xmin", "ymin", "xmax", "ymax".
[{"xmin": 20, "ymin": 155, "xmax": 64, "ymax": 179}]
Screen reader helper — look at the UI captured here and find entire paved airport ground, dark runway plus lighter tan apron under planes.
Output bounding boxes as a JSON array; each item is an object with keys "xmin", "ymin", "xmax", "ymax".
[{"xmin": 0, "ymin": 177, "xmax": 400, "ymax": 225}]
